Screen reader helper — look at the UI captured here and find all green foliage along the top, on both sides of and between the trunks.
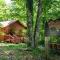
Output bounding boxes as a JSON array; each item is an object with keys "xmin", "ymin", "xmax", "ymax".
[{"xmin": 0, "ymin": 0, "xmax": 60, "ymax": 22}]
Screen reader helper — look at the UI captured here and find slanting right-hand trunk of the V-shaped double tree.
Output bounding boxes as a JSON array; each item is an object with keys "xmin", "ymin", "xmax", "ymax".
[{"xmin": 34, "ymin": 0, "xmax": 42, "ymax": 47}]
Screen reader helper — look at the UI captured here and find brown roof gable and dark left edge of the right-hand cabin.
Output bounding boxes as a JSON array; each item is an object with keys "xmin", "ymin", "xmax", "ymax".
[{"xmin": 45, "ymin": 19, "xmax": 60, "ymax": 36}]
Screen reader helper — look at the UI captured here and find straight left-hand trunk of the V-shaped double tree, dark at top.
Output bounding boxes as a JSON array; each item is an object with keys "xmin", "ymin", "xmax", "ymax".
[{"xmin": 26, "ymin": 0, "xmax": 34, "ymax": 47}]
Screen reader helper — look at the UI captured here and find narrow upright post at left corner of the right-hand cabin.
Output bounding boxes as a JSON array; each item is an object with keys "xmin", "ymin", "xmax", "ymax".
[{"xmin": 45, "ymin": 22, "xmax": 50, "ymax": 60}]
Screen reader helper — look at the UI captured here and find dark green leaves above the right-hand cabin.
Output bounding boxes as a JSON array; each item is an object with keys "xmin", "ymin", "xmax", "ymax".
[{"xmin": 43, "ymin": 0, "xmax": 60, "ymax": 20}]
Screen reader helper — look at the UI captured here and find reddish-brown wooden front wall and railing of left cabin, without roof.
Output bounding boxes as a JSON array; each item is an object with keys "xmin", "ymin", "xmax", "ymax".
[{"xmin": 0, "ymin": 22, "xmax": 25, "ymax": 43}]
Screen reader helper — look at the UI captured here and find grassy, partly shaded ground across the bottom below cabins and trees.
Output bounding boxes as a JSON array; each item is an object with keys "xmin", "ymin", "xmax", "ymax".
[{"xmin": 0, "ymin": 43, "xmax": 60, "ymax": 60}]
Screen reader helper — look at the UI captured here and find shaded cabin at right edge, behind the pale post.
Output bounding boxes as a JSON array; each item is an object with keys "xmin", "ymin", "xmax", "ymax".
[{"xmin": 45, "ymin": 19, "xmax": 60, "ymax": 52}]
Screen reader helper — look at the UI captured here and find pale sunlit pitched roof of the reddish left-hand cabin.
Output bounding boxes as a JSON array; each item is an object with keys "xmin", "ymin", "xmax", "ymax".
[{"xmin": 0, "ymin": 20, "xmax": 27, "ymax": 28}]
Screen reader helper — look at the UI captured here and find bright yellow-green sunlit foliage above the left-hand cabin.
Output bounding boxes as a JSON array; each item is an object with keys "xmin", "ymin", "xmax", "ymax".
[{"xmin": 0, "ymin": 0, "xmax": 26, "ymax": 20}]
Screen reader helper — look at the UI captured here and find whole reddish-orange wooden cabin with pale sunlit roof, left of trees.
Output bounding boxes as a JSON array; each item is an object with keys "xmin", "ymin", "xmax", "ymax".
[{"xmin": 0, "ymin": 20, "xmax": 27, "ymax": 43}]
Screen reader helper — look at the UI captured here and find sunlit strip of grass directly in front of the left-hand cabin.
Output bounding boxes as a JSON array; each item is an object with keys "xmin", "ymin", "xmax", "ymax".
[{"xmin": 0, "ymin": 43, "xmax": 27, "ymax": 50}]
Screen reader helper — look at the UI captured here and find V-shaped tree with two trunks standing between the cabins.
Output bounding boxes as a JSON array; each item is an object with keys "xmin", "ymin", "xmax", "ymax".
[{"xmin": 27, "ymin": 0, "xmax": 42, "ymax": 47}]
